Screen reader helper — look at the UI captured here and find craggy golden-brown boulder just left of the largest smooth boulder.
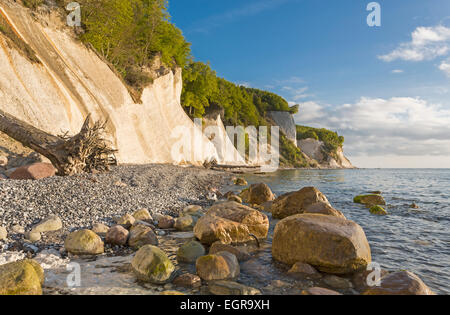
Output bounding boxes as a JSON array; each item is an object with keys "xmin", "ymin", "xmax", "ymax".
[{"xmin": 194, "ymin": 201, "xmax": 269, "ymax": 244}]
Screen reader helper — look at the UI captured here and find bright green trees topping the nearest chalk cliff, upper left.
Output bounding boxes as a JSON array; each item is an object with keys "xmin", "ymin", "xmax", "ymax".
[{"xmin": 55, "ymin": 0, "xmax": 191, "ymax": 97}]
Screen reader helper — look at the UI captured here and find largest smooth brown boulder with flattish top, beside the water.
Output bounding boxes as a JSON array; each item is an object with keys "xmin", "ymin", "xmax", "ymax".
[{"xmin": 272, "ymin": 214, "xmax": 371, "ymax": 274}]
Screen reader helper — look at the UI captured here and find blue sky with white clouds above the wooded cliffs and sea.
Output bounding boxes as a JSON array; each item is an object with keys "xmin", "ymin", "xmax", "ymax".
[{"xmin": 169, "ymin": 0, "xmax": 450, "ymax": 167}]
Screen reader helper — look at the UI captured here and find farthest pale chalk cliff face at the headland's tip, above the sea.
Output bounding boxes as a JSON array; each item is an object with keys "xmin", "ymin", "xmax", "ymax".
[{"xmin": 297, "ymin": 138, "xmax": 355, "ymax": 168}]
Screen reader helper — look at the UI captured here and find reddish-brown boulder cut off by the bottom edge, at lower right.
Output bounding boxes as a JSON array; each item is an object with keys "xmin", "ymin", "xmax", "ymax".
[{"xmin": 363, "ymin": 271, "xmax": 435, "ymax": 295}]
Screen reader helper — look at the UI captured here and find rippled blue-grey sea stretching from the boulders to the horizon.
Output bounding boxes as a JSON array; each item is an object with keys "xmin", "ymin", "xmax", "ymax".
[{"xmin": 245, "ymin": 169, "xmax": 450, "ymax": 294}]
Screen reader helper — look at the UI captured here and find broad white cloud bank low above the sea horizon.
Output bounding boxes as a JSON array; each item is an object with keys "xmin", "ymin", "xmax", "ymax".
[{"xmin": 295, "ymin": 97, "xmax": 450, "ymax": 156}]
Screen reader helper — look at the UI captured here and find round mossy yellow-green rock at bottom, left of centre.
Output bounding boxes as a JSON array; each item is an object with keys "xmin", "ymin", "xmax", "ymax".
[{"xmin": 131, "ymin": 245, "xmax": 175, "ymax": 284}]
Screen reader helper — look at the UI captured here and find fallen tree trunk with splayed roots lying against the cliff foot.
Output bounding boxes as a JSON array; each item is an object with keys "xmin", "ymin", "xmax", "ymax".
[{"xmin": 0, "ymin": 110, "xmax": 117, "ymax": 176}]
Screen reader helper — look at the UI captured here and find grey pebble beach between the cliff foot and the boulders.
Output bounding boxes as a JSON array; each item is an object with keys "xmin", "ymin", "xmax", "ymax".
[{"xmin": 0, "ymin": 165, "xmax": 229, "ymax": 247}]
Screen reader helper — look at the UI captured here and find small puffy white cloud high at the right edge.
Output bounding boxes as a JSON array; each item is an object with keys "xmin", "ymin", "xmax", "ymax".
[{"xmin": 378, "ymin": 25, "xmax": 450, "ymax": 62}]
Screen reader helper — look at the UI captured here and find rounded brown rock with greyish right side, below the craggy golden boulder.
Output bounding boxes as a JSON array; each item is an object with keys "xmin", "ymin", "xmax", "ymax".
[{"xmin": 195, "ymin": 252, "xmax": 240, "ymax": 281}]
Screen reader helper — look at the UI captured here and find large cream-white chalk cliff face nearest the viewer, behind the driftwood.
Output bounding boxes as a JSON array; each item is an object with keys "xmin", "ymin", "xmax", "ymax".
[{"xmin": 0, "ymin": 1, "xmax": 234, "ymax": 164}]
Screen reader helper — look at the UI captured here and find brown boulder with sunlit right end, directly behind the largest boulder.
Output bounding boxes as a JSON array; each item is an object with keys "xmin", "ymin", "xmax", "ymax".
[{"xmin": 270, "ymin": 187, "xmax": 330, "ymax": 219}]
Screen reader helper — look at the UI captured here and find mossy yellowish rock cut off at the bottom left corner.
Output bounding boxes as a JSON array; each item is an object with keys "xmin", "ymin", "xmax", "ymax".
[{"xmin": 0, "ymin": 259, "xmax": 44, "ymax": 295}]
